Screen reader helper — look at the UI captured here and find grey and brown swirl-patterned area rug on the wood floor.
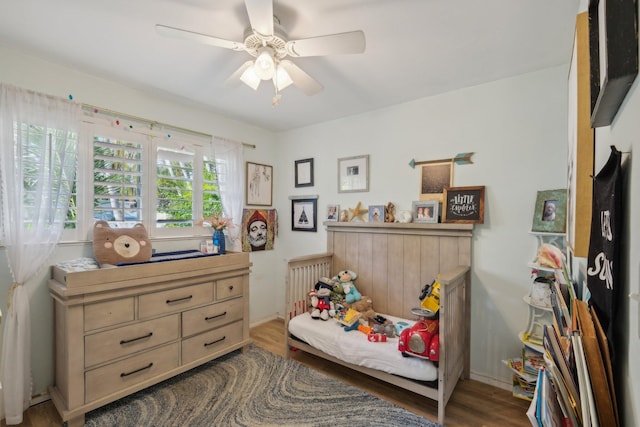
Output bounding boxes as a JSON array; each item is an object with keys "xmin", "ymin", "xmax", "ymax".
[{"xmin": 85, "ymin": 345, "xmax": 438, "ymax": 427}]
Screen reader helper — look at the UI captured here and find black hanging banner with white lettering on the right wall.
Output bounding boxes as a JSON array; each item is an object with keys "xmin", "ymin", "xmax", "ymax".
[{"xmin": 587, "ymin": 146, "xmax": 623, "ymax": 358}]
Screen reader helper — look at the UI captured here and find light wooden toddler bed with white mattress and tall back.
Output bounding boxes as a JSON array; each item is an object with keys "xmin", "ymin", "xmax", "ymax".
[{"xmin": 285, "ymin": 222, "xmax": 473, "ymax": 424}]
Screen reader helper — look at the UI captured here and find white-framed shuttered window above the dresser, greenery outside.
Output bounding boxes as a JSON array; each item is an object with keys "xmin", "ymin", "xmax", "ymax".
[{"xmin": 64, "ymin": 113, "xmax": 222, "ymax": 240}]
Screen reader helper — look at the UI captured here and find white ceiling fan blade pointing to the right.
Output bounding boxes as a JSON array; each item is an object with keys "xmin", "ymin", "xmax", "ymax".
[{"xmin": 286, "ymin": 30, "xmax": 366, "ymax": 57}]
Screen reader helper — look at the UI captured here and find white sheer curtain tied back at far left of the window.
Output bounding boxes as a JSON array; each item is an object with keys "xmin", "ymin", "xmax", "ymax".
[{"xmin": 0, "ymin": 84, "xmax": 81, "ymax": 425}]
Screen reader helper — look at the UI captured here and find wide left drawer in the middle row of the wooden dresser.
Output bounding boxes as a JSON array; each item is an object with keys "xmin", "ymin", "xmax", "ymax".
[{"xmin": 84, "ymin": 314, "xmax": 180, "ymax": 367}]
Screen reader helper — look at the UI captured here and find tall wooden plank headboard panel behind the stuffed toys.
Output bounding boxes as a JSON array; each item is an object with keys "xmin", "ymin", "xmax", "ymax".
[{"xmin": 324, "ymin": 222, "xmax": 473, "ymax": 318}]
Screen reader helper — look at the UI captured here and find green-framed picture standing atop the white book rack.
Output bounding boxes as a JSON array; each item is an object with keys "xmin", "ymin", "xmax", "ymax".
[{"xmin": 531, "ymin": 189, "xmax": 567, "ymax": 233}]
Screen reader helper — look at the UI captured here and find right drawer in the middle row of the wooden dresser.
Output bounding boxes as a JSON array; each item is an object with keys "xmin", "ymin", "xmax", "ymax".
[{"xmin": 182, "ymin": 298, "xmax": 244, "ymax": 337}]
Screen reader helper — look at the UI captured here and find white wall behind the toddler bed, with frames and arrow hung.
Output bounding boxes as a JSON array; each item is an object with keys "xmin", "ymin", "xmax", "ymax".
[{"xmin": 277, "ymin": 67, "xmax": 567, "ymax": 387}]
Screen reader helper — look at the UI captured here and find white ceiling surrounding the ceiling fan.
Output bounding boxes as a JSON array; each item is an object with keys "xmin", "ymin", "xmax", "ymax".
[{"xmin": 0, "ymin": 0, "xmax": 579, "ymax": 131}]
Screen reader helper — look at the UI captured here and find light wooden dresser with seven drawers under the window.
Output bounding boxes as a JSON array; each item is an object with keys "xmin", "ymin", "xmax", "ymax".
[{"xmin": 49, "ymin": 253, "xmax": 251, "ymax": 426}]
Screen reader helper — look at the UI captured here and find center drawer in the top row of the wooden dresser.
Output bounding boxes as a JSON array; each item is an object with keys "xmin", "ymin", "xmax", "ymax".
[{"xmin": 138, "ymin": 282, "xmax": 213, "ymax": 319}]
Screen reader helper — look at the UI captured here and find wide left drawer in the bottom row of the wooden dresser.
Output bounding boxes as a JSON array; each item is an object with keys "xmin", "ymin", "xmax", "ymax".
[{"xmin": 85, "ymin": 342, "xmax": 180, "ymax": 402}]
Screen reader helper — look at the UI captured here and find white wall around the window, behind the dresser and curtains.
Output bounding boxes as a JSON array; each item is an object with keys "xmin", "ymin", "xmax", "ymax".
[{"xmin": 0, "ymin": 45, "xmax": 277, "ymax": 402}]
